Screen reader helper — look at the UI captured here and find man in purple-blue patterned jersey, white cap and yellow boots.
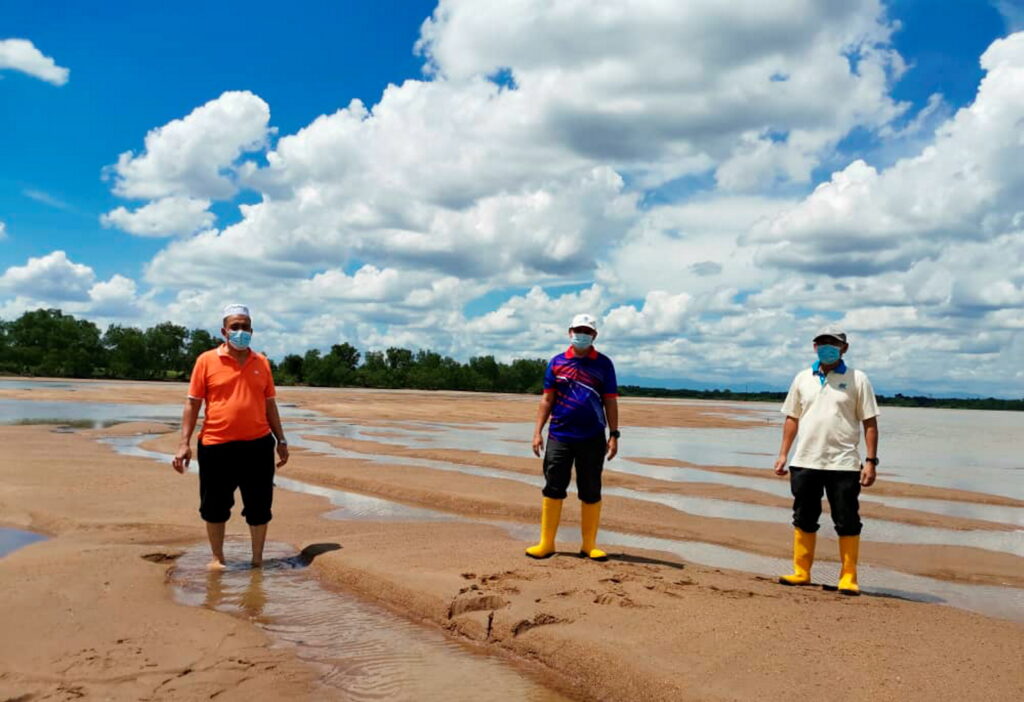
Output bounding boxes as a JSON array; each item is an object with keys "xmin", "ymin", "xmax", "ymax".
[{"xmin": 526, "ymin": 314, "xmax": 618, "ymax": 561}]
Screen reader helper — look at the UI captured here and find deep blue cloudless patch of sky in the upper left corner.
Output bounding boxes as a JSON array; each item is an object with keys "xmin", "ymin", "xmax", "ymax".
[{"xmin": 0, "ymin": 0, "xmax": 434, "ymax": 277}]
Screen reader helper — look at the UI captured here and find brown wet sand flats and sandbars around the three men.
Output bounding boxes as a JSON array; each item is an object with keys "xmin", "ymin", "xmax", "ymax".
[{"xmin": 0, "ymin": 384, "xmax": 1024, "ymax": 700}]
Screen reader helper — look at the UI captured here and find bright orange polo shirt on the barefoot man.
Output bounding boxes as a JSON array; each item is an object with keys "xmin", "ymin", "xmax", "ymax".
[{"xmin": 188, "ymin": 344, "xmax": 278, "ymax": 446}]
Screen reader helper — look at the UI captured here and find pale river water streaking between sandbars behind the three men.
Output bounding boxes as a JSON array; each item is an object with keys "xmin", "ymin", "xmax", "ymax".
[{"xmin": 0, "ymin": 381, "xmax": 1024, "ymax": 620}]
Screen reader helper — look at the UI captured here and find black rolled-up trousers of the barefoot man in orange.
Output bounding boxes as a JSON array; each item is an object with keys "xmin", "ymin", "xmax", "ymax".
[{"xmin": 197, "ymin": 434, "xmax": 276, "ymax": 526}]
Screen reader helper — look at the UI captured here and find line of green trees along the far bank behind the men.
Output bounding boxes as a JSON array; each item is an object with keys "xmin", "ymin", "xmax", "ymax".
[{"xmin": 0, "ymin": 309, "xmax": 1024, "ymax": 411}]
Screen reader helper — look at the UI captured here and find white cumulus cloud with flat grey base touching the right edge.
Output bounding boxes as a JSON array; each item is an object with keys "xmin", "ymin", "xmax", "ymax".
[{"xmin": 752, "ymin": 33, "xmax": 1024, "ymax": 275}]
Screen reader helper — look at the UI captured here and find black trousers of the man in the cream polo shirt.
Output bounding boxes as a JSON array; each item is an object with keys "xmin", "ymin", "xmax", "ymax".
[{"xmin": 790, "ymin": 466, "xmax": 862, "ymax": 536}]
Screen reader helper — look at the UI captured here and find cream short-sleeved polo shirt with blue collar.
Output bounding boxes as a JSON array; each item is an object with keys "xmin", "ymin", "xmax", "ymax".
[{"xmin": 782, "ymin": 362, "xmax": 879, "ymax": 471}]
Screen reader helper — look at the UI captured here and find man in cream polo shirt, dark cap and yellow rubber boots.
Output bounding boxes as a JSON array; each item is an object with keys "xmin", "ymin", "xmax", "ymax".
[{"xmin": 775, "ymin": 325, "xmax": 879, "ymax": 595}]
